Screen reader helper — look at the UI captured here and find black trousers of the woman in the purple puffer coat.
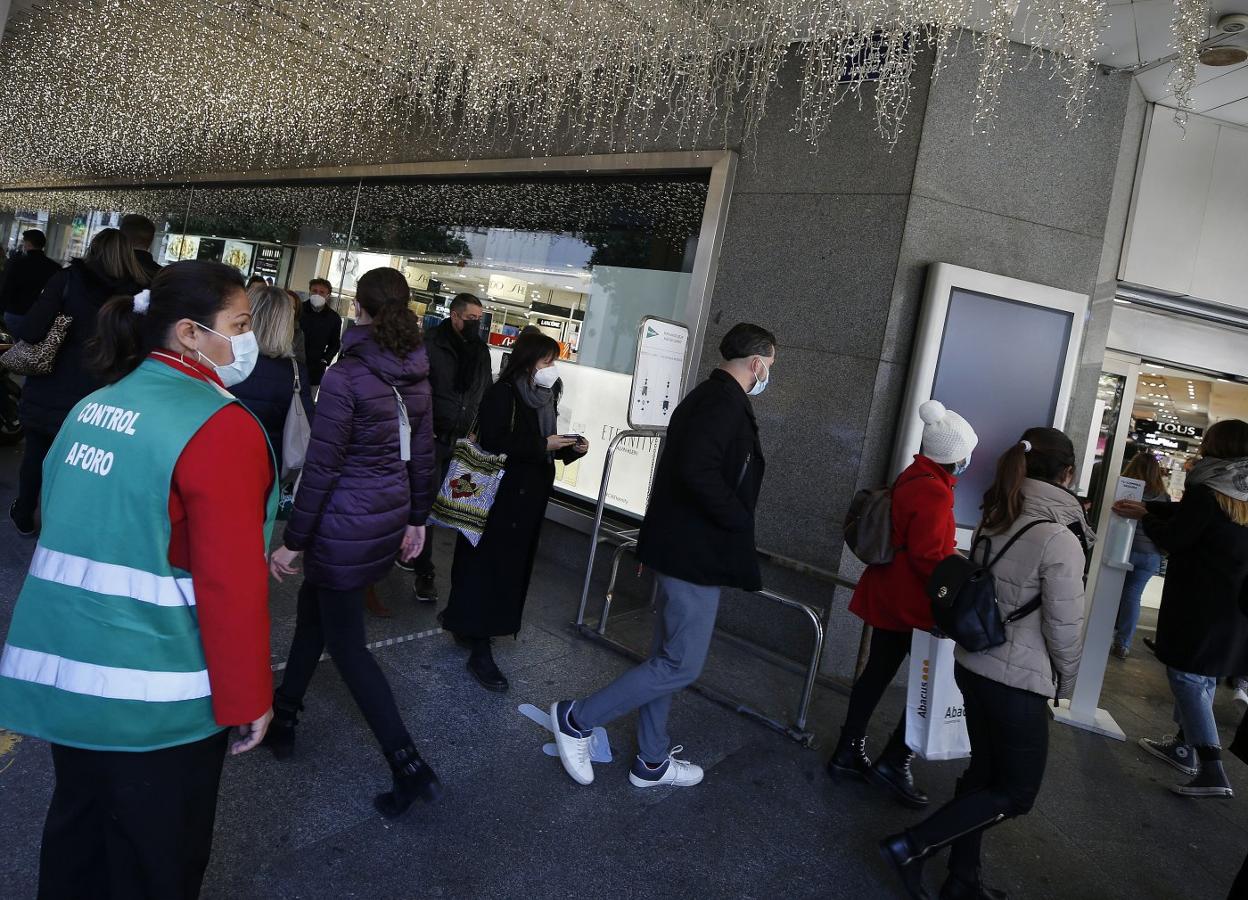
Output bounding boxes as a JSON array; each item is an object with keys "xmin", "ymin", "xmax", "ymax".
[{"xmin": 277, "ymin": 580, "xmax": 412, "ymax": 753}]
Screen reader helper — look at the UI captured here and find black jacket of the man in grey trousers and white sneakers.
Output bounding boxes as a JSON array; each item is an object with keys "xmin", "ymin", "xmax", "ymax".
[{"xmin": 638, "ymin": 369, "xmax": 766, "ymax": 590}]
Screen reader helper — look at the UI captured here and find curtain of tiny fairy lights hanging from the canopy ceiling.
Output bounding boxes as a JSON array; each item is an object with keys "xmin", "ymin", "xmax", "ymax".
[{"xmin": 0, "ymin": 0, "xmax": 1208, "ymax": 185}]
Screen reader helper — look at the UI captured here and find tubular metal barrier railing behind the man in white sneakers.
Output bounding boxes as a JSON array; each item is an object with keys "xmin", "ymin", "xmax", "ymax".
[{"xmin": 575, "ymin": 431, "xmax": 854, "ymax": 746}]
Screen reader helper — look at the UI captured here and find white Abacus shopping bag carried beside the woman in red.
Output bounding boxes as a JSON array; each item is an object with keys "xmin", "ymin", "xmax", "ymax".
[{"xmin": 906, "ymin": 629, "xmax": 971, "ymax": 759}]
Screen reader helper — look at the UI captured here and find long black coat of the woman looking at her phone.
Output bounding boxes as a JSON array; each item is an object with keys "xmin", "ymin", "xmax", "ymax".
[{"xmin": 442, "ymin": 381, "xmax": 582, "ymax": 638}]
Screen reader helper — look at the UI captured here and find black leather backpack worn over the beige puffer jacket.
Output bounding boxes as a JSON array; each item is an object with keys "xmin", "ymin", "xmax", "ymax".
[{"xmin": 927, "ymin": 519, "xmax": 1056, "ymax": 653}]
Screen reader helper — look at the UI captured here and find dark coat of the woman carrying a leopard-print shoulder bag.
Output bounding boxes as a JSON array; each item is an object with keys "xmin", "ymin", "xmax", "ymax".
[{"xmin": 17, "ymin": 260, "xmax": 141, "ymax": 434}]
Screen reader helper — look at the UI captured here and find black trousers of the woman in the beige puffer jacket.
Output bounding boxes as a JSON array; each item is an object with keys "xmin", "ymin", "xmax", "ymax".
[{"xmin": 910, "ymin": 665, "xmax": 1048, "ymax": 883}]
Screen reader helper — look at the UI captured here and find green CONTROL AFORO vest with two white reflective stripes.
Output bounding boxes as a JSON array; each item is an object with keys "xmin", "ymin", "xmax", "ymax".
[{"xmin": 0, "ymin": 360, "xmax": 277, "ymax": 751}]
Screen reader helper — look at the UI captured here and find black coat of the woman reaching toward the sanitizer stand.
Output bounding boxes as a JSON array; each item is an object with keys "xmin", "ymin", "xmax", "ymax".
[{"xmin": 1141, "ymin": 486, "xmax": 1248, "ymax": 677}]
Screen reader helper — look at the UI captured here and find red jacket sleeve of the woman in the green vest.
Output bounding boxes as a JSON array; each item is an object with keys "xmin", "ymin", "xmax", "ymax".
[{"xmin": 170, "ymin": 403, "xmax": 273, "ymax": 725}]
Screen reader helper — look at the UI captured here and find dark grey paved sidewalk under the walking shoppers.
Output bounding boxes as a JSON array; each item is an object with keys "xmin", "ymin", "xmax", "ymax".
[{"xmin": 0, "ymin": 439, "xmax": 1248, "ymax": 900}]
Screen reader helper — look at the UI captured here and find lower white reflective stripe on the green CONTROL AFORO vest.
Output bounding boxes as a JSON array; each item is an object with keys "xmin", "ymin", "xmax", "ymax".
[{"xmin": 0, "ymin": 644, "xmax": 212, "ymax": 703}]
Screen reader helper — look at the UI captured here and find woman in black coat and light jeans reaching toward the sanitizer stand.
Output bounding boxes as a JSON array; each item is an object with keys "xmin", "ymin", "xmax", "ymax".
[{"xmin": 1113, "ymin": 419, "xmax": 1248, "ymax": 796}]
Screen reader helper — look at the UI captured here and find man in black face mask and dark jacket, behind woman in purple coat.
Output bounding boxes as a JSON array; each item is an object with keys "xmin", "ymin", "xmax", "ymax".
[{"xmin": 399, "ymin": 293, "xmax": 492, "ymax": 603}]
